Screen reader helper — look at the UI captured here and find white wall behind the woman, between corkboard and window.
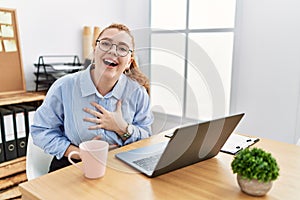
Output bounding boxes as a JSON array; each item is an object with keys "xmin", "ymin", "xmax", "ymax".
[{"xmin": 0, "ymin": 0, "xmax": 149, "ymax": 90}]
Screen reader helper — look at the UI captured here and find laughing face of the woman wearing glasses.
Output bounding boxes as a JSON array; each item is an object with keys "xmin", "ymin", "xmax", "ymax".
[{"xmin": 94, "ymin": 28, "xmax": 133, "ymax": 80}]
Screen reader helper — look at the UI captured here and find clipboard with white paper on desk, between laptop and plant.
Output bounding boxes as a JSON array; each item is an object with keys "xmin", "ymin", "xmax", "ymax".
[{"xmin": 221, "ymin": 134, "xmax": 259, "ymax": 155}]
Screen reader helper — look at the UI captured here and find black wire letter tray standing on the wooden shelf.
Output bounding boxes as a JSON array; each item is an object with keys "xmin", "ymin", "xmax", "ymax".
[{"xmin": 34, "ymin": 55, "xmax": 84, "ymax": 91}]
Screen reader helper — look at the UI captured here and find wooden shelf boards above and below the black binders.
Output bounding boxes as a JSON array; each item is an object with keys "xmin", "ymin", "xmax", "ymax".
[{"xmin": 0, "ymin": 92, "xmax": 45, "ymax": 199}]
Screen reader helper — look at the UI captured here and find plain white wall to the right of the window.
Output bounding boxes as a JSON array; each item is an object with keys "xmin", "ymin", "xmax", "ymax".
[{"xmin": 231, "ymin": 0, "xmax": 300, "ymax": 143}]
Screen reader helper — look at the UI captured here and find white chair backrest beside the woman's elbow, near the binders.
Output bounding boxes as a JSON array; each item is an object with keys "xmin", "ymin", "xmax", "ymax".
[{"xmin": 26, "ymin": 134, "xmax": 53, "ymax": 180}]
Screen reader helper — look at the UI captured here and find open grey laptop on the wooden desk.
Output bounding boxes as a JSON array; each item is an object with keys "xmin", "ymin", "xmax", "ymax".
[{"xmin": 115, "ymin": 113, "xmax": 244, "ymax": 177}]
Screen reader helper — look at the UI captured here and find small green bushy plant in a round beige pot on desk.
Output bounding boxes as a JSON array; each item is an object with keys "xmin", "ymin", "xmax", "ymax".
[{"xmin": 231, "ymin": 147, "xmax": 279, "ymax": 196}]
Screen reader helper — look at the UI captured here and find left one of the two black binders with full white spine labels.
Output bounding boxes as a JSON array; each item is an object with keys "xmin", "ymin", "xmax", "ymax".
[{"xmin": 0, "ymin": 108, "xmax": 18, "ymax": 161}]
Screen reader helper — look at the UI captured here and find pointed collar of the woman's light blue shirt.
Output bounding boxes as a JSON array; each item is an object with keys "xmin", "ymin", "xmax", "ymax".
[{"xmin": 80, "ymin": 65, "xmax": 127, "ymax": 99}]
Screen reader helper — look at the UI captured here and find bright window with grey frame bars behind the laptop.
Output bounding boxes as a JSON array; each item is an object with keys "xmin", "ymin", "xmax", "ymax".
[{"xmin": 150, "ymin": 0, "xmax": 236, "ymax": 120}]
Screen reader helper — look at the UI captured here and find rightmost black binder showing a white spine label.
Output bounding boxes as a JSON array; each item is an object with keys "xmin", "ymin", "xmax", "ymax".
[{"xmin": 5, "ymin": 106, "xmax": 27, "ymax": 157}]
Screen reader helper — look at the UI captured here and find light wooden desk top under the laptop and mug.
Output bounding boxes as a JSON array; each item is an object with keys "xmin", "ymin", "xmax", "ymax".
[{"xmin": 20, "ymin": 134, "xmax": 300, "ymax": 200}]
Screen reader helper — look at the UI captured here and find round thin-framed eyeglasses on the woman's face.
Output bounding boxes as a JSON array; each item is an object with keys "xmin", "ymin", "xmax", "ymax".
[{"xmin": 96, "ymin": 39, "xmax": 132, "ymax": 57}]
